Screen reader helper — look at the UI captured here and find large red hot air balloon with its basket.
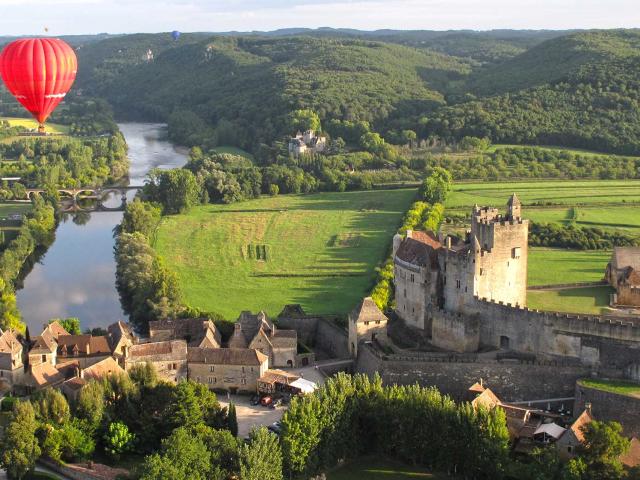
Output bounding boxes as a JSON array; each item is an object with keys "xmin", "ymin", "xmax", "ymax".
[{"xmin": 0, "ymin": 38, "xmax": 78, "ymax": 132}]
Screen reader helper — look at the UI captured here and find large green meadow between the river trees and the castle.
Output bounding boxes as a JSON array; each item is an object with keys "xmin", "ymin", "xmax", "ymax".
[{"xmin": 155, "ymin": 189, "xmax": 415, "ymax": 319}]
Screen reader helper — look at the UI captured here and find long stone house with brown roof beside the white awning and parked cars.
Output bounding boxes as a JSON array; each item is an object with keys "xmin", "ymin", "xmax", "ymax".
[{"xmin": 187, "ymin": 348, "xmax": 269, "ymax": 393}]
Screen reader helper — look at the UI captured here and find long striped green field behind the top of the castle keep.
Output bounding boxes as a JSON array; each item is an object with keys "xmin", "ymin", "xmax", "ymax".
[{"xmin": 446, "ymin": 180, "xmax": 640, "ymax": 209}]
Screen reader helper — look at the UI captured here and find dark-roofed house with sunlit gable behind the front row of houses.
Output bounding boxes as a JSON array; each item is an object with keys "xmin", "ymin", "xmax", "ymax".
[{"xmin": 149, "ymin": 318, "xmax": 222, "ymax": 348}]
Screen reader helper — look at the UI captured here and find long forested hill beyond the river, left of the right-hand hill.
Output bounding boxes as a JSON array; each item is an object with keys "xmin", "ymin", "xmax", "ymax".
[{"xmin": 78, "ymin": 35, "xmax": 470, "ymax": 149}]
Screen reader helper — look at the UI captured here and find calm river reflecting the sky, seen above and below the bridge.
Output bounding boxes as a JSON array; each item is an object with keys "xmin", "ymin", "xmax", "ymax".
[{"xmin": 17, "ymin": 123, "xmax": 187, "ymax": 335}]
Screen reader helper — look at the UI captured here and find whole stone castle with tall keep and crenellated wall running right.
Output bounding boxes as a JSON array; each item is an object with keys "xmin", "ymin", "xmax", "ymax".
[{"xmin": 393, "ymin": 194, "xmax": 640, "ymax": 378}]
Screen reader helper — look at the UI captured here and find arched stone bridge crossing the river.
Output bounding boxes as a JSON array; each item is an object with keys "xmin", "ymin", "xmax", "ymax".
[{"xmin": 24, "ymin": 186, "xmax": 142, "ymax": 212}]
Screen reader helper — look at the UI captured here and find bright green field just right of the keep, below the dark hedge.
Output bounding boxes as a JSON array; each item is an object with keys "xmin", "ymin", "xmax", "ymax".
[{"xmin": 528, "ymin": 247, "xmax": 611, "ymax": 286}]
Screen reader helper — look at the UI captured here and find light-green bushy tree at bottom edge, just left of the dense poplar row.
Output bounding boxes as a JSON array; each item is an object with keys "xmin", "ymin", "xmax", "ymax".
[{"xmin": 240, "ymin": 427, "xmax": 282, "ymax": 480}]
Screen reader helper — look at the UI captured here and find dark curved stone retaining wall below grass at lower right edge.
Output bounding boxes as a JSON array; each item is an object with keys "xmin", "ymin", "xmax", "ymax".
[{"xmin": 574, "ymin": 382, "xmax": 640, "ymax": 437}]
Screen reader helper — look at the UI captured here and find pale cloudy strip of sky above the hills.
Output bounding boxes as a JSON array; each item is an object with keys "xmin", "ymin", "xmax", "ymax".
[{"xmin": 0, "ymin": 0, "xmax": 640, "ymax": 36}]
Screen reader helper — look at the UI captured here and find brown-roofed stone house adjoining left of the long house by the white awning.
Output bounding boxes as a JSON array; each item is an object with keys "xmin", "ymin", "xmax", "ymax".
[{"xmin": 124, "ymin": 340, "xmax": 188, "ymax": 382}]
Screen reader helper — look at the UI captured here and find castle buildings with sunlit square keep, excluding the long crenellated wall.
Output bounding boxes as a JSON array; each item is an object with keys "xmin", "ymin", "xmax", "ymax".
[{"xmin": 393, "ymin": 194, "xmax": 529, "ymax": 330}]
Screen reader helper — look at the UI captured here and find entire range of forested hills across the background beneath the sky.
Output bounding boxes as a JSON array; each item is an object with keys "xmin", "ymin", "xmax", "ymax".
[{"xmin": 5, "ymin": 29, "xmax": 640, "ymax": 159}]
